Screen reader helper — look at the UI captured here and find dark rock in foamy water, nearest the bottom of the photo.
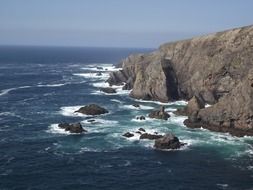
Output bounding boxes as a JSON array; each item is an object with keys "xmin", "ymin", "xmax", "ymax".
[{"xmin": 154, "ymin": 133, "xmax": 183, "ymax": 149}]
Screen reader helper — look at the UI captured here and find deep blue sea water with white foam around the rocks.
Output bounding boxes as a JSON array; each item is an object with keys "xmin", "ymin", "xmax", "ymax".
[{"xmin": 0, "ymin": 47, "xmax": 253, "ymax": 190}]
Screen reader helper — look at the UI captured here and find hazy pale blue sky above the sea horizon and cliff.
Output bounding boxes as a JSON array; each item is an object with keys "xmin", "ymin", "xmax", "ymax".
[{"xmin": 0, "ymin": 0, "xmax": 253, "ymax": 48}]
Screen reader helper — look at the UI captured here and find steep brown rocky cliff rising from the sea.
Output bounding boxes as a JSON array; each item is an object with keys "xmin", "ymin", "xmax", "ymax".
[{"xmin": 108, "ymin": 26, "xmax": 253, "ymax": 134}]
